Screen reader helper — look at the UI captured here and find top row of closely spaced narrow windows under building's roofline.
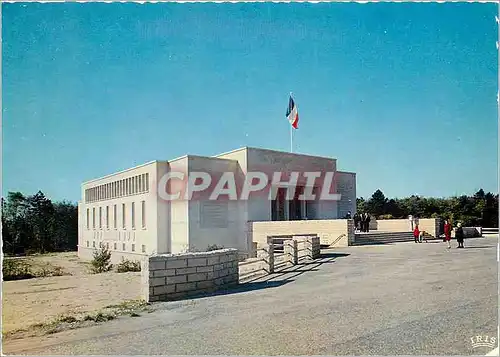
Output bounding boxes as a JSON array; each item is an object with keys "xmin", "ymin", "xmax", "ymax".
[{"xmin": 85, "ymin": 173, "xmax": 149, "ymax": 203}]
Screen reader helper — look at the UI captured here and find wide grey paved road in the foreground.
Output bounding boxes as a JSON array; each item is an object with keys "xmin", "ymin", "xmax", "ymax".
[{"xmin": 4, "ymin": 237, "xmax": 498, "ymax": 355}]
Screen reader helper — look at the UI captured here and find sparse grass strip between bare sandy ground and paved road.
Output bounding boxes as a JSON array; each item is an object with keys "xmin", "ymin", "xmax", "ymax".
[{"xmin": 3, "ymin": 300, "xmax": 152, "ymax": 339}]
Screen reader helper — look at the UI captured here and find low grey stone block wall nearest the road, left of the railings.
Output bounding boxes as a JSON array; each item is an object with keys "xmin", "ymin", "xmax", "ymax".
[{"xmin": 141, "ymin": 249, "xmax": 239, "ymax": 302}]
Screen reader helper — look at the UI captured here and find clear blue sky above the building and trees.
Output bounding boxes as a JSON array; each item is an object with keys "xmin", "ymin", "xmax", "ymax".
[{"xmin": 2, "ymin": 3, "xmax": 498, "ymax": 201}]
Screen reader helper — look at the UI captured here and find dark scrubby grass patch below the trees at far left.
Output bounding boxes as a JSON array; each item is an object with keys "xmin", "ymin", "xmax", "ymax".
[{"xmin": 2, "ymin": 258, "xmax": 71, "ymax": 281}]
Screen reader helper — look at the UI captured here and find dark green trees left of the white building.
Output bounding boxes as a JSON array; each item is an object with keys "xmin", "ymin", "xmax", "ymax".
[{"xmin": 2, "ymin": 191, "xmax": 78, "ymax": 254}]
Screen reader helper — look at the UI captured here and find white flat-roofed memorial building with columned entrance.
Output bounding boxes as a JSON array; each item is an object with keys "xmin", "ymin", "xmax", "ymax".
[{"xmin": 78, "ymin": 147, "xmax": 356, "ymax": 262}]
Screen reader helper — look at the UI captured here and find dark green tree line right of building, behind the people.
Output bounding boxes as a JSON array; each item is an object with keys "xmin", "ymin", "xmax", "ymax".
[{"xmin": 356, "ymin": 189, "xmax": 498, "ymax": 228}]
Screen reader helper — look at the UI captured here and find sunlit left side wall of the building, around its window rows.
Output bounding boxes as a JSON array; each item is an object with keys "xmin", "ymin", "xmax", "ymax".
[{"xmin": 78, "ymin": 161, "xmax": 158, "ymax": 260}]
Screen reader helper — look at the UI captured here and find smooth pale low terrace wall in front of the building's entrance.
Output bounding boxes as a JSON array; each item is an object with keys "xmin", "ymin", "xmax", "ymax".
[{"xmin": 248, "ymin": 219, "xmax": 354, "ymax": 247}]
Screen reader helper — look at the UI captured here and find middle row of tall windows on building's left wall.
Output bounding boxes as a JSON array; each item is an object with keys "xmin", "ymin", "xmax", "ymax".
[{"xmin": 86, "ymin": 201, "xmax": 146, "ymax": 230}]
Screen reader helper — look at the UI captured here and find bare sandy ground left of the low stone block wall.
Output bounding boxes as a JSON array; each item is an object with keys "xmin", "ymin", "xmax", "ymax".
[{"xmin": 2, "ymin": 252, "xmax": 145, "ymax": 338}]
